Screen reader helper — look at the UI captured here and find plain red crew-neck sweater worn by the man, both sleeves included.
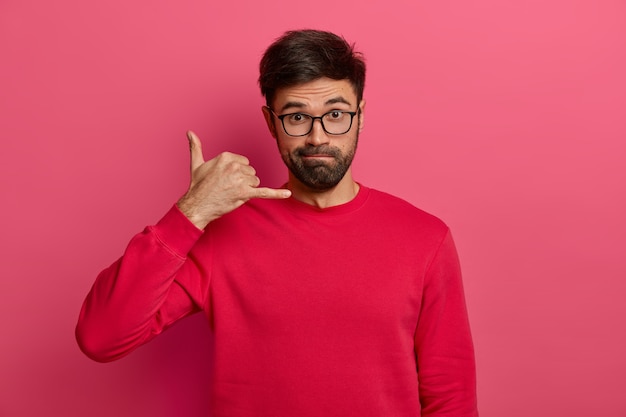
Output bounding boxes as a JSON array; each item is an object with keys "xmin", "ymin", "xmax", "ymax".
[{"xmin": 76, "ymin": 186, "xmax": 477, "ymax": 417}]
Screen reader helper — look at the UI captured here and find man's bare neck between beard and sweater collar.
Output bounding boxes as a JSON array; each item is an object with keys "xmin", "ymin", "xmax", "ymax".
[{"xmin": 287, "ymin": 170, "xmax": 359, "ymax": 208}]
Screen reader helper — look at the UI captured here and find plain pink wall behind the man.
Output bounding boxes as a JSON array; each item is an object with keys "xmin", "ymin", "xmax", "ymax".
[{"xmin": 0, "ymin": 0, "xmax": 626, "ymax": 417}]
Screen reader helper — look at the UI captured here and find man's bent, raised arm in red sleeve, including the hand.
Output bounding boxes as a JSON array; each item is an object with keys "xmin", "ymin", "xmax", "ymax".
[{"xmin": 76, "ymin": 132, "xmax": 291, "ymax": 362}]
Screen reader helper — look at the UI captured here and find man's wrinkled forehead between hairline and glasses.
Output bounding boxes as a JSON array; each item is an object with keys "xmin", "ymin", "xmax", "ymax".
[{"xmin": 273, "ymin": 78, "xmax": 357, "ymax": 111}]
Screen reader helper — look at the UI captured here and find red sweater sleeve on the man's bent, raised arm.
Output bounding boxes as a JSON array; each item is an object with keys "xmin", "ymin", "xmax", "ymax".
[{"xmin": 76, "ymin": 206, "xmax": 203, "ymax": 362}]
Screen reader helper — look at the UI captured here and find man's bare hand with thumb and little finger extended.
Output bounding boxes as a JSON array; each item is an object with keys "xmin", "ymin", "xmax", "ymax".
[{"xmin": 177, "ymin": 131, "xmax": 291, "ymax": 229}]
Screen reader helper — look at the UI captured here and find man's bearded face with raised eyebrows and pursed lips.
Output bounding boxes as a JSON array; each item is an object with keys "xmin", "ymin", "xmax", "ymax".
[{"xmin": 263, "ymin": 78, "xmax": 364, "ymax": 191}]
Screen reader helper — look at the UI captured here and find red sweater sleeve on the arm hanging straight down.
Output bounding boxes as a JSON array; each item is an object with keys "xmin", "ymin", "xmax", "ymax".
[{"xmin": 415, "ymin": 230, "xmax": 478, "ymax": 417}]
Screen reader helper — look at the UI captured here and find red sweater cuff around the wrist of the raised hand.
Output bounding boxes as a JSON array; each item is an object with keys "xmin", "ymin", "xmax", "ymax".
[{"xmin": 151, "ymin": 204, "xmax": 204, "ymax": 258}]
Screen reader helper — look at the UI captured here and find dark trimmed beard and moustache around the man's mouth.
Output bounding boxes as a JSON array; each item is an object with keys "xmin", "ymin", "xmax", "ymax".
[{"xmin": 283, "ymin": 143, "xmax": 356, "ymax": 191}]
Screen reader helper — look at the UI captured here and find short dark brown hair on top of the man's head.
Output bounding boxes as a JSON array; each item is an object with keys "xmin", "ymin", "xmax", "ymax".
[{"xmin": 259, "ymin": 29, "xmax": 365, "ymax": 106}]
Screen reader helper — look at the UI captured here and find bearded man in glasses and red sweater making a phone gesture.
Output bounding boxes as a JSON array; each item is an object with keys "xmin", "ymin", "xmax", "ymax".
[{"xmin": 76, "ymin": 30, "xmax": 477, "ymax": 417}]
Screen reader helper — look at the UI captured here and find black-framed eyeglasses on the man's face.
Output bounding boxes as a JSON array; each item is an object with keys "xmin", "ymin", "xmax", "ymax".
[{"xmin": 268, "ymin": 107, "xmax": 358, "ymax": 136}]
